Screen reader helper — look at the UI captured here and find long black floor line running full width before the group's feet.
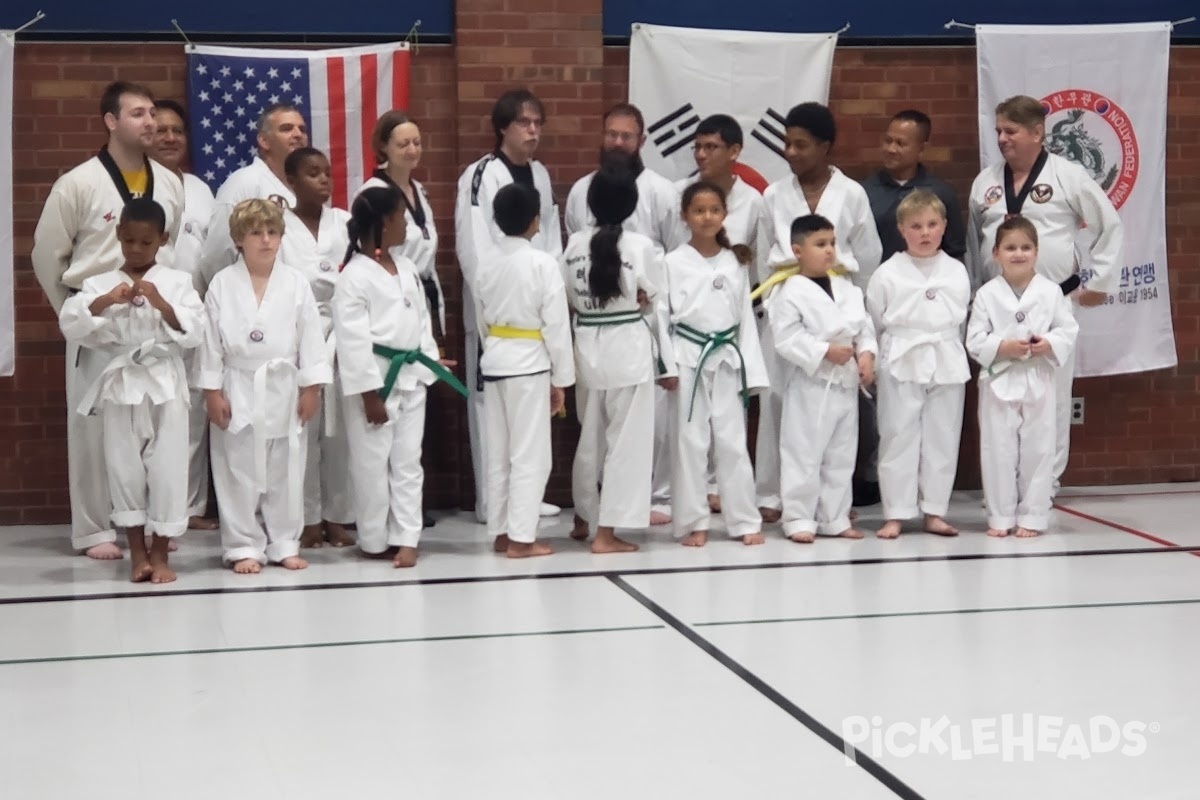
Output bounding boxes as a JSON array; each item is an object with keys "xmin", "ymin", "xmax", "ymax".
[{"xmin": 0, "ymin": 545, "xmax": 1200, "ymax": 606}]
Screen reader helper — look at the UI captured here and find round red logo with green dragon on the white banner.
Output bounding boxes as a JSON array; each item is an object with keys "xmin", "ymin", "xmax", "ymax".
[{"xmin": 1033, "ymin": 89, "xmax": 1141, "ymax": 209}]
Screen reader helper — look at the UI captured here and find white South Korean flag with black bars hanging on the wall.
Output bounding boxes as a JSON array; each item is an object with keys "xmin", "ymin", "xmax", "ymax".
[{"xmin": 629, "ymin": 23, "xmax": 838, "ymax": 191}]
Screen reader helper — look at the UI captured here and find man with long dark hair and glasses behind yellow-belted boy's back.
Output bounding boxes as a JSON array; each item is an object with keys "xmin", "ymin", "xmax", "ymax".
[{"xmin": 455, "ymin": 89, "xmax": 563, "ymax": 523}]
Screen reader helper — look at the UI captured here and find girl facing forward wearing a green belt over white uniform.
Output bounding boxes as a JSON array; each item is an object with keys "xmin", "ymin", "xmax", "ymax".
[{"xmin": 659, "ymin": 181, "xmax": 767, "ymax": 547}]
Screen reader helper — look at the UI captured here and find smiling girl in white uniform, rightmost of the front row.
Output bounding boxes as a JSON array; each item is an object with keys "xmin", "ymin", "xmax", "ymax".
[{"xmin": 967, "ymin": 217, "xmax": 1079, "ymax": 539}]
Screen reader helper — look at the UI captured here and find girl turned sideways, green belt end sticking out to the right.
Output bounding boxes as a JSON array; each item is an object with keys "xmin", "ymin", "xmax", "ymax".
[{"xmin": 334, "ymin": 186, "xmax": 467, "ymax": 567}]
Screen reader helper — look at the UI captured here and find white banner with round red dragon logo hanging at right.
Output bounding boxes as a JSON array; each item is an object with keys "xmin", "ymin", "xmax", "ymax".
[{"xmin": 976, "ymin": 23, "xmax": 1176, "ymax": 375}]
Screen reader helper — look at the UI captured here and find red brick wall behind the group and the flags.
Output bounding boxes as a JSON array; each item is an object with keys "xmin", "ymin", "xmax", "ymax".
[{"xmin": 0, "ymin": 32, "xmax": 1200, "ymax": 524}]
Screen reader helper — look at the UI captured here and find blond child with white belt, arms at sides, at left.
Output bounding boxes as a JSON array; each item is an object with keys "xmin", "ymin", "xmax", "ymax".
[{"xmin": 196, "ymin": 199, "xmax": 332, "ymax": 573}]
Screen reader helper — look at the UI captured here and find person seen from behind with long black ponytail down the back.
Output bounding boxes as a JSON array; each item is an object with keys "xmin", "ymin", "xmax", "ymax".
[{"xmin": 563, "ymin": 167, "xmax": 662, "ymax": 553}]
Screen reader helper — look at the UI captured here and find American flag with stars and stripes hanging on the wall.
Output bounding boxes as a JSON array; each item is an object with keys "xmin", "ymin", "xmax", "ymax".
[{"xmin": 187, "ymin": 42, "xmax": 409, "ymax": 209}]
